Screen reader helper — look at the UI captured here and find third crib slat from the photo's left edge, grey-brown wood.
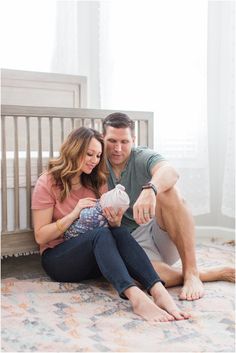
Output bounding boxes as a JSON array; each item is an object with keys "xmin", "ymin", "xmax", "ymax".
[{"xmin": 25, "ymin": 116, "xmax": 32, "ymax": 228}]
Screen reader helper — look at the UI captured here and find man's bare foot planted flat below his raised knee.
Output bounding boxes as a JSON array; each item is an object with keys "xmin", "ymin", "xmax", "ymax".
[{"xmin": 179, "ymin": 275, "xmax": 204, "ymax": 300}]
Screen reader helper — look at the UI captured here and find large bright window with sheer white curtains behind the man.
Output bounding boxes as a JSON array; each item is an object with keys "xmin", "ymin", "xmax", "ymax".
[{"xmin": 100, "ymin": 0, "xmax": 209, "ymax": 215}]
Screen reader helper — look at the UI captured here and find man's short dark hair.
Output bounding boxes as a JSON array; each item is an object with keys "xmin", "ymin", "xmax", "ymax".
[{"xmin": 102, "ymin": 112, "xmax": 135, "ymax": 136}]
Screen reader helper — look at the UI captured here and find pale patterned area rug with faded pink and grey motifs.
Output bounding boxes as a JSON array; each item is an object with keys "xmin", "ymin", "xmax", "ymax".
[{"xmin": 2, "ymin": 244, "xmax": 235, "ymax": 352}]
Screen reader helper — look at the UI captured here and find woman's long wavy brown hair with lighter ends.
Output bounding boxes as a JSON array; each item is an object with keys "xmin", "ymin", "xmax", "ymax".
[{"xmin": 47, "ymin": 127, "xmax": 108, "ymax": 202}]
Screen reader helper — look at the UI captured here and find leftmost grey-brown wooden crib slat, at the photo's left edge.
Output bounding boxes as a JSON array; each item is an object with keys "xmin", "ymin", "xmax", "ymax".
[{"xmin": 1, "ymin": 116, "xmax": 7, "ymax": 232}]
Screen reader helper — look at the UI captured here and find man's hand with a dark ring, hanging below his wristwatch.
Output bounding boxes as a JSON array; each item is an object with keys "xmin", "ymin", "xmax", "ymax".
[{"xmin": 133, "ymin": 189, "xmax": 156, "ymax": 224}]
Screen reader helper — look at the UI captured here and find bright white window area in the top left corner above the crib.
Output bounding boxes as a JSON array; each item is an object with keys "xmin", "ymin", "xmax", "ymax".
[{"xmin": 0, "ymin": 0, "xmax": 57, "ymax": 72}]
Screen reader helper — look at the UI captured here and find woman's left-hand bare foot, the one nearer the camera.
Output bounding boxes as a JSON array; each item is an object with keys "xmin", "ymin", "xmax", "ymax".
[{"xmin": 124, "ymin": 286, "xmax": 174, "ymax": 323}]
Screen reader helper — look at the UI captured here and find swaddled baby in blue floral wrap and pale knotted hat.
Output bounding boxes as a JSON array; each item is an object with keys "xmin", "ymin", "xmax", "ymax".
[{"xmin": 64, "ymin": 184, "xmax": 130, "ymax": 240}]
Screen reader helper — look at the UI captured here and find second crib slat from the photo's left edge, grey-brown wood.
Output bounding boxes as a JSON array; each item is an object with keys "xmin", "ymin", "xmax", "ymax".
[{"xmin": 14, "ymin": 116, "xmax": 20, "ymax": 230}]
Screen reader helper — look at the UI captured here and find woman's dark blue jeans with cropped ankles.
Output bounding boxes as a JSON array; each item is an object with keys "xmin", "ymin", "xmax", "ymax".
[{"xmin": 42, "ymin": 226, "xmax": 161, "ymax": 298}]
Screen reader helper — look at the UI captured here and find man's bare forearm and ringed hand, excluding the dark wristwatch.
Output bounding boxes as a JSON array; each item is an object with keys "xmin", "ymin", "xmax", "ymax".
[{"xmin": 133, "ymin": 161, "xmax": 179, "ymax": 224}]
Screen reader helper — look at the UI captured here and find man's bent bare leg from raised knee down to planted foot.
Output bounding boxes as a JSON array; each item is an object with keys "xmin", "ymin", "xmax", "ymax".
[{"xmin": 156, "ymin": 188, "xmax": 203, "ymax": 300}]
